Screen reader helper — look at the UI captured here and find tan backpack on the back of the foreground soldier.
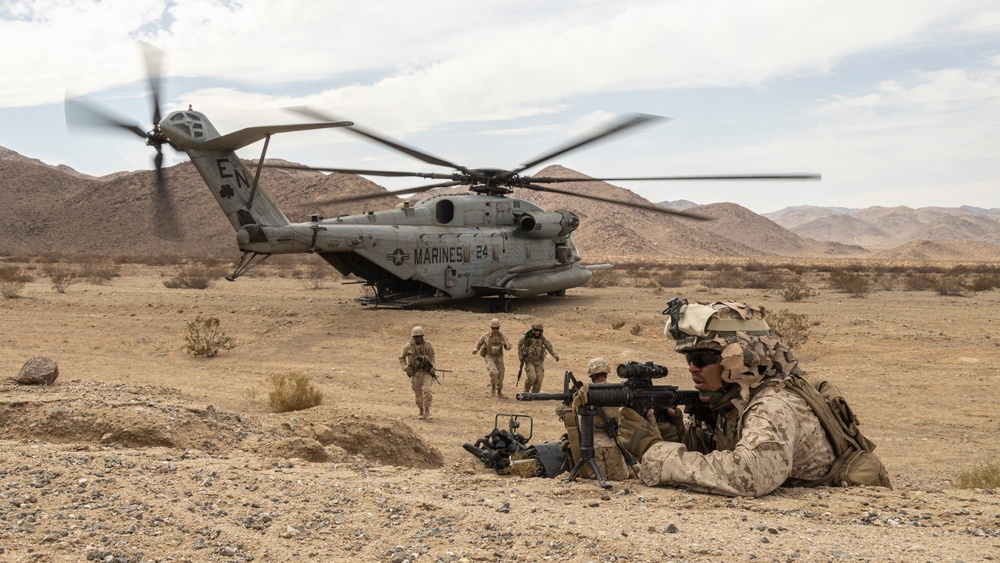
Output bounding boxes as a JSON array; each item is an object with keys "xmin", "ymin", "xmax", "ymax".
[{"xmin": 785, "ymin": 377, "xmax": 892, "ymax": 489}]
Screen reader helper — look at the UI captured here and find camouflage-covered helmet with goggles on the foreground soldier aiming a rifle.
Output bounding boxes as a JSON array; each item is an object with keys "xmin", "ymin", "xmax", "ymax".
[{"xmin": 664, "ymin": 300, "xmax": 799, "ymax": 393}]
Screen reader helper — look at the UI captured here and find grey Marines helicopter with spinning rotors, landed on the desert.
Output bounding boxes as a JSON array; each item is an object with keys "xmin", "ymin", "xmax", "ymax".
[{"xmin": 66, "ymin": 44, "xmax": 818, "ymax": 312}]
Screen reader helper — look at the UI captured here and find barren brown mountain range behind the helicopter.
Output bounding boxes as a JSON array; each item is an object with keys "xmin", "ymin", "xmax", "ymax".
[{"xmin": 0, "ymin": 147, "xmax": 1000, "ymax": 261}]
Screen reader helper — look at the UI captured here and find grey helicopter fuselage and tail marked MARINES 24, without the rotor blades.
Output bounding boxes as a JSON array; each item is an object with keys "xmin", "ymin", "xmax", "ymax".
[{"xmin": 162, "ymin": 110, "xmax": 591, "ymax": 310}]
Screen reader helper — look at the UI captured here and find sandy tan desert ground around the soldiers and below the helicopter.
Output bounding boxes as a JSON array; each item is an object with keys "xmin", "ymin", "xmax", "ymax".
[{"xmin": 0, "ymin": 265, "xmax": 1000, "ymax": 562}]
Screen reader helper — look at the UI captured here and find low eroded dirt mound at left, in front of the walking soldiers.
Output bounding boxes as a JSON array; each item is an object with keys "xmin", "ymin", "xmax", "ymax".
[{"xmin": 0, "ymin": 382, "xmax": 443, "ymax": 469}]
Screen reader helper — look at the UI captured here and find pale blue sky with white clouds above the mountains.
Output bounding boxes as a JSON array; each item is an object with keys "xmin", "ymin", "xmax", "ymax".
[{"xmin": 0, "ymin": 0, "xmax": 1000, "ymax": 213}]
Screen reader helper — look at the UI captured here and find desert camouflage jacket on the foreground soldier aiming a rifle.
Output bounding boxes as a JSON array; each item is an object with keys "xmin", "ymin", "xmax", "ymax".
[{"xmin": 639, "ymin": 387, "xmax": 834, "ymax": 497}]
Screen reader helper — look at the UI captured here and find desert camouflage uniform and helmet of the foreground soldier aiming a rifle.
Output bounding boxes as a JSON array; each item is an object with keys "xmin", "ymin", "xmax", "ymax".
[{"xmin": 619, "ymin": 302, "xmax": 835, "ymax": 497}]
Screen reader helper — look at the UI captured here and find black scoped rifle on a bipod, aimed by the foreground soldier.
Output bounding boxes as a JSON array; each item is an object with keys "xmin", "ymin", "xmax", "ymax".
[{"xmin": 516, "ymin": 362, "xmax": 701, "ymax": 489}]
